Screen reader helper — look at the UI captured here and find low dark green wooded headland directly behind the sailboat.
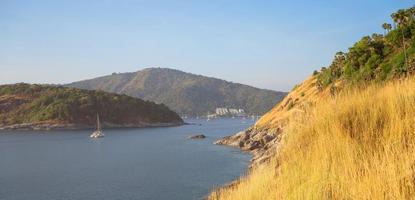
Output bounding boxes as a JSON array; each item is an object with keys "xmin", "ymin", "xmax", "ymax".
[{"xmin": 0, "ymin": 84, "xmax": 183, "ymax": 128}]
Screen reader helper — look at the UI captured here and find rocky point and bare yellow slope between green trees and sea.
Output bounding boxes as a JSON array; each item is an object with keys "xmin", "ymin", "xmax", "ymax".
[{"xmin": 215, "ymin": 76, "xmax": 324, "ymax": 165}]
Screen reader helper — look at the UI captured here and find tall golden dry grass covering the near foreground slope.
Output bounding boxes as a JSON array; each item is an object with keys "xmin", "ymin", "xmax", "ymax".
[{"xmin": 210, "ymin": 79, "xmax": 415, "ymax": 200}]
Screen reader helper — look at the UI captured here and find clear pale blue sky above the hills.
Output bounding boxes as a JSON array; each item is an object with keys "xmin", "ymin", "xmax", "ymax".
[{"xmin": 0, "ymin": 0, "xmax": 415, "ymax": 91}]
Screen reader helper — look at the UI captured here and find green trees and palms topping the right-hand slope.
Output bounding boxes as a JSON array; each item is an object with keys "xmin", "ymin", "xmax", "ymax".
[{"xmin": 313, "ymin": 7, "xmax": 415, "ymax": 87}]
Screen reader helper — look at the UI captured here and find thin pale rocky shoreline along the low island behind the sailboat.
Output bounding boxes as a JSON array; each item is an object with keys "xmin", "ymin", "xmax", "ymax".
[{"xmin": 0, "ymin": 122, "xmax": 185, "ymax": 131}]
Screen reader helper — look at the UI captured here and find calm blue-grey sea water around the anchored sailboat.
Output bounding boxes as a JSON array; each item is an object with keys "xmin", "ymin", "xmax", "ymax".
[{"xmin": 0, "ymin": 119, "xmax": 253, "ymax": 200}]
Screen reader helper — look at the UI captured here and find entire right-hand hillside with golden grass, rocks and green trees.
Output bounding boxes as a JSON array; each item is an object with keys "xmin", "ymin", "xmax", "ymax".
[{"xmin": 210, "ymin": 7, "xmax": 415, "ymax": 200}]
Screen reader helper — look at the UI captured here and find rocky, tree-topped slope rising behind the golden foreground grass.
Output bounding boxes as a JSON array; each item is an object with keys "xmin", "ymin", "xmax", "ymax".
[{"xmin": 217, "ymin": 5, "xmax": 415, "ymax": 166}]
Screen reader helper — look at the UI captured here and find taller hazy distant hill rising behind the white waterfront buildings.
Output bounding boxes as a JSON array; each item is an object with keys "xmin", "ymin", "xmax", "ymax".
[{"xmin": 67, "ymin": 68, "xmax": 286, "ymax": 115}]
